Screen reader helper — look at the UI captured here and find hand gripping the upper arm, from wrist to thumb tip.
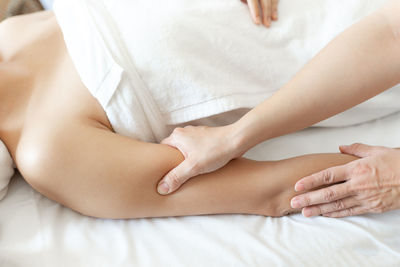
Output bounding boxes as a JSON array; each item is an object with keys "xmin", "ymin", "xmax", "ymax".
[{"xmin": 157, "ymin": 125, "xmax": 240, "ymax": 195}]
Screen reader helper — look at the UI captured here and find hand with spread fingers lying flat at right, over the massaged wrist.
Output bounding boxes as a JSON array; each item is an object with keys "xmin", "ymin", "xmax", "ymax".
[{"xmin": 291, "ymin": 144, "xmax": 400, "ymax": 217}]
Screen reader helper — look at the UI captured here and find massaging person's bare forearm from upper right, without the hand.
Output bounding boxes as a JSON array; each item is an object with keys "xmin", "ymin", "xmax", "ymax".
[{"xmin": 234, "ymin": 1, "xmax": 400, "ymax": 155}]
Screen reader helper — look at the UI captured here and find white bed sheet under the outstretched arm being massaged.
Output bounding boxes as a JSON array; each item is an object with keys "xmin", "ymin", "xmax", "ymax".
[{"xmin": 0, "ymin": 113, "xmax": 400, "ymax": 267}]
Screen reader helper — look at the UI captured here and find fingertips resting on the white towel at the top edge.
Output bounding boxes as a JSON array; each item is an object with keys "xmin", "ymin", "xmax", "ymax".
[{"xmin": 241, "ymin": 0, "xmax": 279, "ymax": 27}]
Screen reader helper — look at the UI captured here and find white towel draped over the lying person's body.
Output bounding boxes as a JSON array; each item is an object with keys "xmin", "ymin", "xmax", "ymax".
[{"xmin": 54, "ymin": 0, "xmax": 400, "ymax": 144}]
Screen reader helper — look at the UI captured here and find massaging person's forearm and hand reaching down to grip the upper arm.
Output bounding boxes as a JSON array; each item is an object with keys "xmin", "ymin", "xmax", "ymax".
[{"xmin": 159, "ymin": 0, "xmax": 400, "ymax": 199}]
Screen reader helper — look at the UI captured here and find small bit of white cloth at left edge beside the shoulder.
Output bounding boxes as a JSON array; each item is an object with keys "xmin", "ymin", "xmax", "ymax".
[{"xmin": 0, "ymin": 140, "xmax": 14, "ymax": 200}]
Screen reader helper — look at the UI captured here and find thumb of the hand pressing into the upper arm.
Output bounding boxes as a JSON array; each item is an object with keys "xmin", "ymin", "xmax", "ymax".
[{"xmin": 157, "ymin": 159, "xmax": 198, "ymax": 195}]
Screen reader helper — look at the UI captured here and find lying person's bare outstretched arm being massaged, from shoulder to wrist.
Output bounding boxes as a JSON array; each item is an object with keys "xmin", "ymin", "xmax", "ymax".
[{"xmin": 17, "ymin": 120, "xmax": 355, "ymax": 218}]
